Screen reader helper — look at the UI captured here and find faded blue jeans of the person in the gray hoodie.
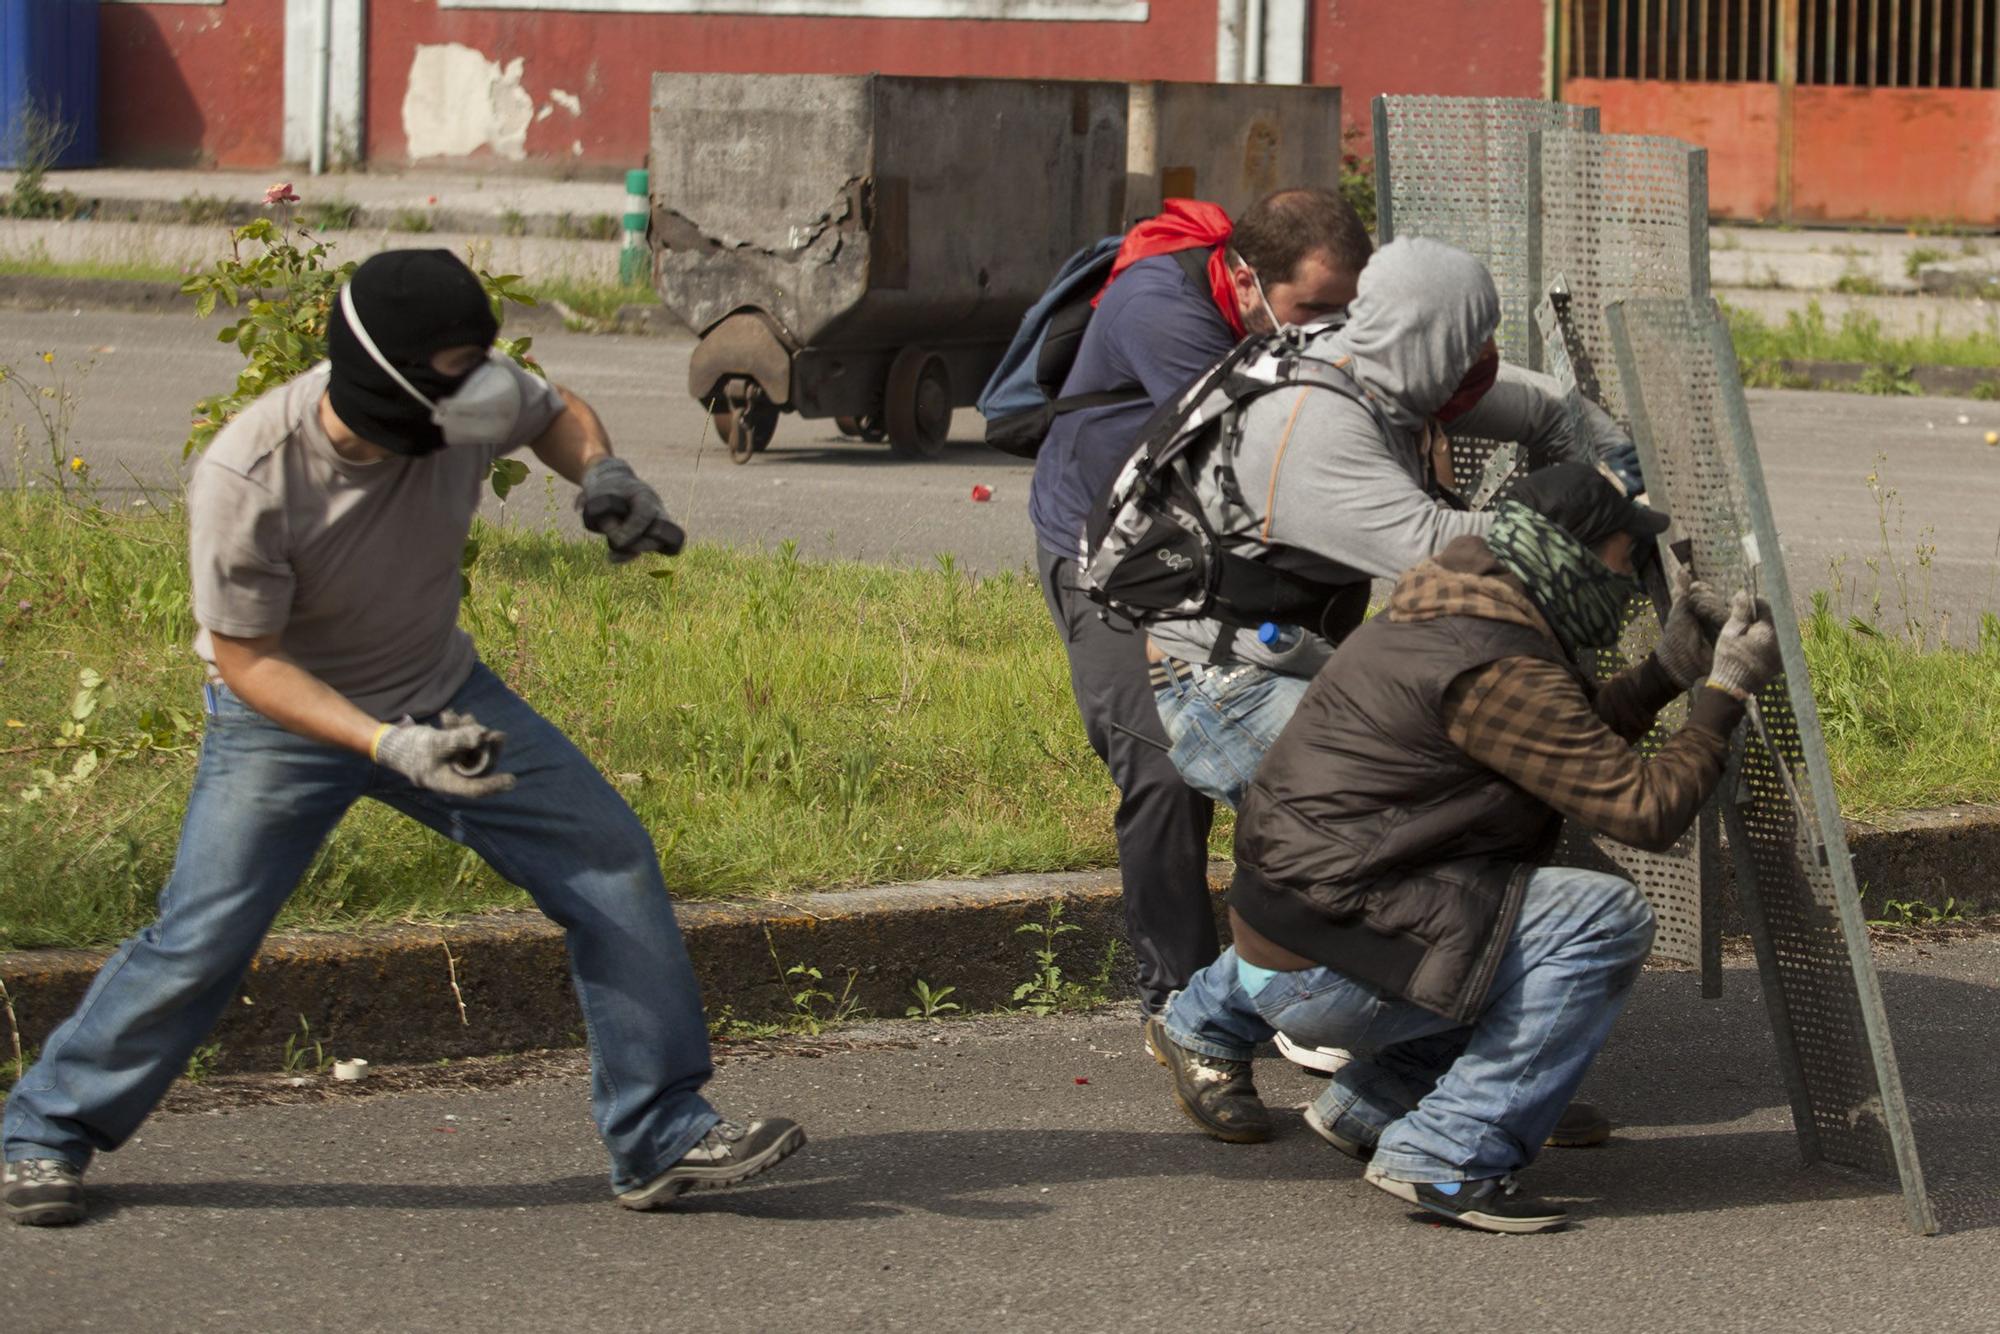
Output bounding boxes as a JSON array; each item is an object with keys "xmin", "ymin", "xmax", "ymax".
[{"xmin": 1154, "ymin": 662, "xmax": 1312, "ymax": 810}]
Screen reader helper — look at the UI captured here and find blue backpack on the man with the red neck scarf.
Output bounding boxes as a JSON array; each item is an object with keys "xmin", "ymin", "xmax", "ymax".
[{"xmin": 978, "ymin": 236, "xmax": 1210, "ymax": 458}]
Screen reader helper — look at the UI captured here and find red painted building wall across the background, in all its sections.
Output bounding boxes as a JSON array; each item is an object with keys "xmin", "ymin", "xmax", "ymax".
[{"xmin": 100, "ymin": 0, "xmax": 1546, "ymax": 168}]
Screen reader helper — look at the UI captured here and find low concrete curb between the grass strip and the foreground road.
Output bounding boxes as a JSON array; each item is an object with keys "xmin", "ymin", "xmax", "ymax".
[{"xmin": 0, "ymin": 806, "xmax": 2000, "ymax": 1068}]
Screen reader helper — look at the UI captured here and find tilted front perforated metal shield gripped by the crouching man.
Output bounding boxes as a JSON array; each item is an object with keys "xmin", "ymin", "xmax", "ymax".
[{"xmin": 1610, "ymin": 300, "xmax": 1936, "ymax": 1232}]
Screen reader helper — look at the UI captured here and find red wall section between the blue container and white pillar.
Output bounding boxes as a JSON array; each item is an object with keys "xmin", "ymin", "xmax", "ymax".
[{"xmin": 98, "ymin": 0, "xmax": 284, "ymax": 166}]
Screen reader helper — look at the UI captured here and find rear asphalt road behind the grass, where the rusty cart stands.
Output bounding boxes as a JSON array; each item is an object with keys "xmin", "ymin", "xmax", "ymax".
[{"xmin": 0, "ymin": 310, "xmax": 2000, "ymax": 638}]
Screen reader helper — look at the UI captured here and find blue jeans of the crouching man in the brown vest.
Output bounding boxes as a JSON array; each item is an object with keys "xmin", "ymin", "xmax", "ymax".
[{"xmin": 1166, "ymin": 866, "xmax": 1652, "ymax": 1182}]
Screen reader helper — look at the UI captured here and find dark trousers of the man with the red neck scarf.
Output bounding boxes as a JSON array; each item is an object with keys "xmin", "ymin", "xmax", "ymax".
[{"xmin": 1036, "ymin": 546, "xmax": 1220, "ymax": 1014}]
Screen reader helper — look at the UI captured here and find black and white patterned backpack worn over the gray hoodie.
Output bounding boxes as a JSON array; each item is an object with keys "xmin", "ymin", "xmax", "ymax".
[{"xmin": 1078, "ymin": 326, "xmax": 1388, "ymax": 640}]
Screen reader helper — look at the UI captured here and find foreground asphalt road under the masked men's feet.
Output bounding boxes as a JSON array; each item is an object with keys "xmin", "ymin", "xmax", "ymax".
[{"xmin": 0, "ymin": 938, "xmax": 2000, "ymax": 1334}]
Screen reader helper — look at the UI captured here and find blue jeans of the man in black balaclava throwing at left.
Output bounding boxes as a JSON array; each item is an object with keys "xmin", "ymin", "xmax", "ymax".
[{"xmin": 4, "ymin": 664, "xmax": 718, "ymax": 1190}]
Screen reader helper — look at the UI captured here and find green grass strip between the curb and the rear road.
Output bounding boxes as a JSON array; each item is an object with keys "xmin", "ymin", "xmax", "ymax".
[{"xmin": 0, "ymin": 482, "xmax": 2000, "ymax": 948}]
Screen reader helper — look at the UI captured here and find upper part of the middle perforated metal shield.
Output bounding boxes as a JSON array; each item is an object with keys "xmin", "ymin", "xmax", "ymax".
[{"xmin": 1528, "ymin": 130, "xmax": 1708, "ymax": 424}]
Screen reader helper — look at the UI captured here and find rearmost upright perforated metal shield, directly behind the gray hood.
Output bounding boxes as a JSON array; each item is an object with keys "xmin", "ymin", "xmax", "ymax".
[{"xmin": 1374, "ymin": 96, "xmax": 1598, "ymax": 366}]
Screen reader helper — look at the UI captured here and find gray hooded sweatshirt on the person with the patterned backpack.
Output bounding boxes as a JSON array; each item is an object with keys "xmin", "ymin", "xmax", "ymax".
[{"xmin": 1150, "ymin": 238, "xmax": 1624, "ymax": 676}]
